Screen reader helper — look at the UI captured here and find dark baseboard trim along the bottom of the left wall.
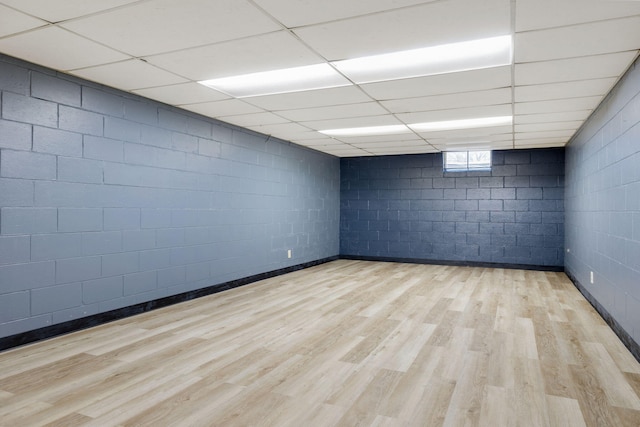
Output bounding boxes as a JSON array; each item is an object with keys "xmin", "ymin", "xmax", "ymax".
[{"xmin": 0, "ymin": 256, "xmax": 339, "ymax": 351}]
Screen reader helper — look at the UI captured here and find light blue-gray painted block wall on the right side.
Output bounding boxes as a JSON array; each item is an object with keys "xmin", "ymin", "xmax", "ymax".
[{"xmin": 565, "ymin": 56, "xmax": 640, "ymax": 343}]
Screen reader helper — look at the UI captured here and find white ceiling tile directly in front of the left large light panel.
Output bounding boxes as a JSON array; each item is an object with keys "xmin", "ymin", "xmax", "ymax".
[{"xmin": 145, "ymin": 31, "xmax": 322, "ymax": 80}]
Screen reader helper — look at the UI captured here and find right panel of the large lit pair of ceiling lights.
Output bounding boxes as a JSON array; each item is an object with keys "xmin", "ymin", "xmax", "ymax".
[{"xmin": 332, "ymin": 36, "xmax": 512, "ymax": 83}]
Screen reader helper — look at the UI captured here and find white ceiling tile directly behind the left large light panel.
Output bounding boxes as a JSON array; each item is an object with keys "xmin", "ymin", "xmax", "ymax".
[{"xmin": 245, "ymin": 86, "xmax": 371, "ymax": 111}]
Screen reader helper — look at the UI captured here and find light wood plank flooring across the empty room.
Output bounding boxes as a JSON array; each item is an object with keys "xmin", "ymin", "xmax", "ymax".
[{"xmin": 0, "ymin": 260, "xmax": 640, "ymax": 427}]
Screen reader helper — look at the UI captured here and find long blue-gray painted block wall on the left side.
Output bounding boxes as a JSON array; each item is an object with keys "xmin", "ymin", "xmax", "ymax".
[{"xmin": 0, "ymin": 56, "xmax": 340, "ymax": 337}]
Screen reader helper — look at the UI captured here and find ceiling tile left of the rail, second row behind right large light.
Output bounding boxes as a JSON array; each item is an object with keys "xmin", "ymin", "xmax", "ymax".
[{"xmin": 381, "ymin": 88, "xmax": 511, "ymax": 113}]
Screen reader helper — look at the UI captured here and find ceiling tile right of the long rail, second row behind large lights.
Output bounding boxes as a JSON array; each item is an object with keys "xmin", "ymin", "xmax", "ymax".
[{"xmin": 515, "ymin": 77, "xmax": 618, "ymax": 102}]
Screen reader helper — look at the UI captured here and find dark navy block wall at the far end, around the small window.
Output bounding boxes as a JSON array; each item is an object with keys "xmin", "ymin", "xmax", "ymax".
[{"xmin": 340, "ymin": 148, "xmax": 564, "ymax": 267}]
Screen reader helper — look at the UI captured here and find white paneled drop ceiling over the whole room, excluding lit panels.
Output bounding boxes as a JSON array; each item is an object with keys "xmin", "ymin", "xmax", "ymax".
[{"xmin": 0, "ymin": 0, "xmax": 640, "ymax": 157}]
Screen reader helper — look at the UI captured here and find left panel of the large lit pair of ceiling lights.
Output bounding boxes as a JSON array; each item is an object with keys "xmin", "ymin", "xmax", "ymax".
[{"xmin": 199, "ymin": 64, "xmax": 351, "ymax": 98}]
